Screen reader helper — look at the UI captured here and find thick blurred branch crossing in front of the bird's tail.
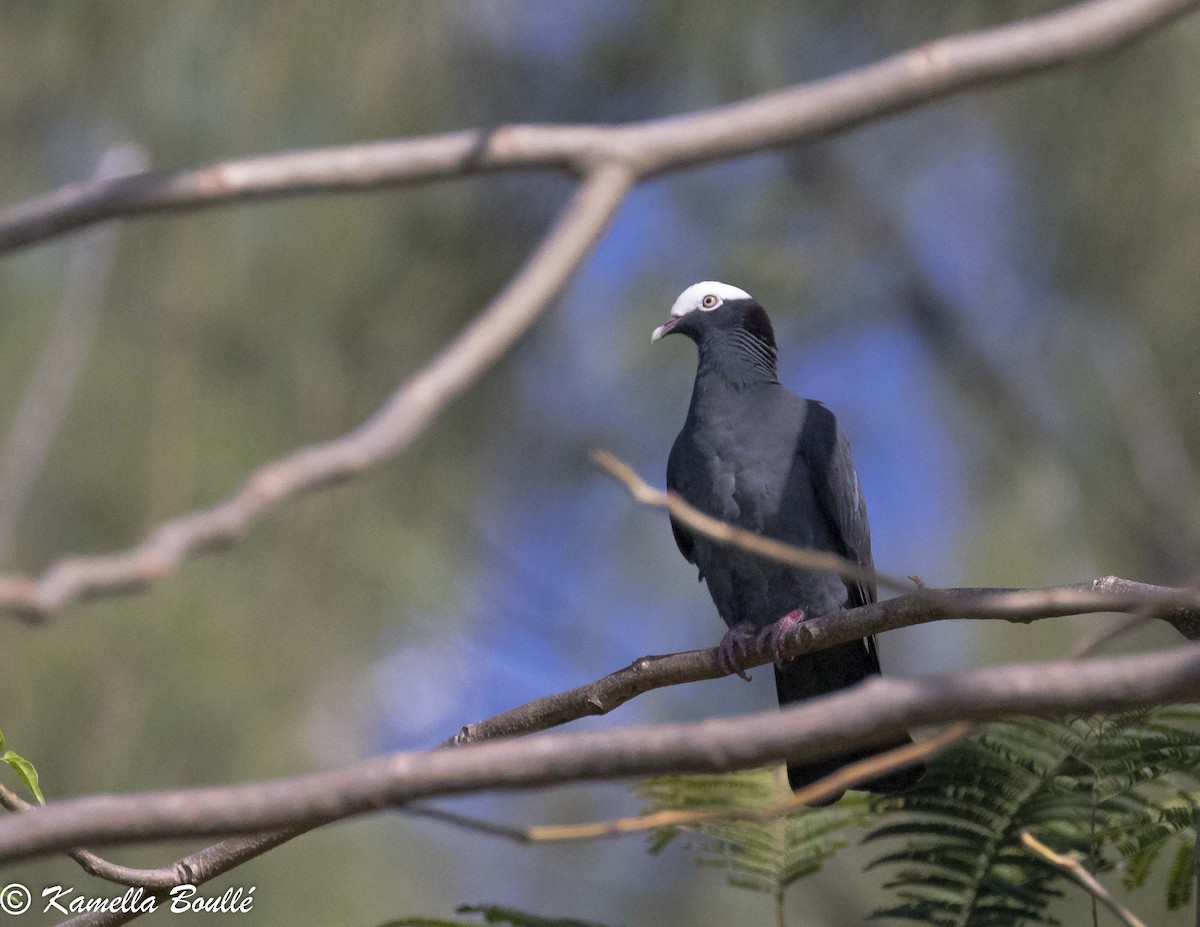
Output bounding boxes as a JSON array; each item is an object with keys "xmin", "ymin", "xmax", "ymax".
[{"xmin": 0, "ymin": 646, "xmax": 1200, "ymax": 862}]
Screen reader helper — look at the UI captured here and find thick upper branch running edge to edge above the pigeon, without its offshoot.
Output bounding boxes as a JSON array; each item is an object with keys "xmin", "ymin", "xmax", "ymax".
[{"xmin": 0, "ymin": 0, "xmax": 1200, "ymax": 252}]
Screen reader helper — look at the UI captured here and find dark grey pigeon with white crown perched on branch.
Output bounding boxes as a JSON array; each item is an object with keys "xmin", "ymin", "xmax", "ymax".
[{"xmin": 650, "ymin": 281, "xmax": 923, "ymax": 801}]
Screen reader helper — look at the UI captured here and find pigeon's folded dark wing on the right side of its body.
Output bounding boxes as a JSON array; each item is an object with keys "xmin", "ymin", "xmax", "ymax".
[{"xmin": 802, "ymin": 400, "xmax": 876, "ymax": 609}]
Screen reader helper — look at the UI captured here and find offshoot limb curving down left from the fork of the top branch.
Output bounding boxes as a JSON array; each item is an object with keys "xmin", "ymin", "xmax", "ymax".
[{"xmin": 0, "ymin": 167, "xmax": 631, "ymax": 621}]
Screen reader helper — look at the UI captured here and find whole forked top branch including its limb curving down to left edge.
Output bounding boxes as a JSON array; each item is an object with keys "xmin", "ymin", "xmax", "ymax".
[{"xmin": 0, "ymin": 0, "xmax": 1185, "ymax": 620}]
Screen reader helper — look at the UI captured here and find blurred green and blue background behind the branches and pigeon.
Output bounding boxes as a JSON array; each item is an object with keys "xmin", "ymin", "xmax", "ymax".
[{"xmin": 0, "ymin": 0, "xmax": 1200, "ymax": 927}]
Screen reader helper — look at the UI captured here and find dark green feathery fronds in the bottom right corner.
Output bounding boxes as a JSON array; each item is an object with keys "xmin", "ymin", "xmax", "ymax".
[{"xmin": 868, "ymin": 706, "xmax": 1200, "ymax": 927}]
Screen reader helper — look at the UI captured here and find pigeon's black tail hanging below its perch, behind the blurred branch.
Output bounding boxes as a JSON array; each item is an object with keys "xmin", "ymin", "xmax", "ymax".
[{"xmin": 775, "ymin": 640, "xmax": 925, "ymax": 803}]
